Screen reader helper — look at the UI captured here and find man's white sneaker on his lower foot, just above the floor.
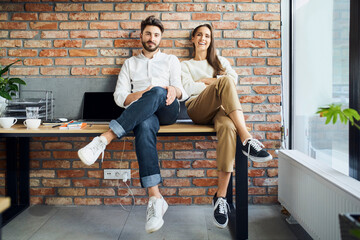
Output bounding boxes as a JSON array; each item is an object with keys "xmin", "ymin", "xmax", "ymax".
[{"xmin": 145, "ymin": 197, "xmax": 168, "ymax": 233}]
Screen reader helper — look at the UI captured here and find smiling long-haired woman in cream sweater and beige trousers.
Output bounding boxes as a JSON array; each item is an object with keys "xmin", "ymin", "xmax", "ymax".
[{"xmin": 181, "ymin": 24, "xmax": 272, "ymax": 228}]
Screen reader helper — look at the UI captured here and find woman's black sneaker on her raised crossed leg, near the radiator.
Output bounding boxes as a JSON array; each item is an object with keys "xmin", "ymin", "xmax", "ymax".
[{"xmin": 242, "ymin": 138, "xmax": 272, "ymax": 162}]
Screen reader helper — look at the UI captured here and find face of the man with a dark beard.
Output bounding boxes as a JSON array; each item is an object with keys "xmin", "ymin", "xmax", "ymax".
[{"xmin": 140, "ymin": 25, "xmax": 161, "ymax": 52}]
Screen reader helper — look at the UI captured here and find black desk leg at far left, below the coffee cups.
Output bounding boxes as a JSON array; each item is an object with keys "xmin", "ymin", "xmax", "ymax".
[{"xmin": 2, "ymin": 137, "xmax": 30, "ymax": 225}]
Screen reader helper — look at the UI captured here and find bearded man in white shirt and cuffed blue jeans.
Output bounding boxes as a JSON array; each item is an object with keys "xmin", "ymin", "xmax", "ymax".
[{"xmin": 78, "ymin": 16, "xmax": 187, "ymax": 233}]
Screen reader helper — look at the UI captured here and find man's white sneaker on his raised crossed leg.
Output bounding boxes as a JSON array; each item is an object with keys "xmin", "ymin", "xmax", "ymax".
[{"xmin": 78, "ymin": 137, "xmax": 106, "ymax": 166}]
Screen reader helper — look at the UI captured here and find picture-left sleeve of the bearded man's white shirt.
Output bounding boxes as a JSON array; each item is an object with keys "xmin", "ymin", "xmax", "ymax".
[{"xmin": 114, "ymin": 59, "xmax": 131, "ymax": 108}]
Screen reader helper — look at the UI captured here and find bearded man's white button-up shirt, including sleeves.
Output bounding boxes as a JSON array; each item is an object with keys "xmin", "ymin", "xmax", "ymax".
[{"xmin": 114, "ymin": 50, "xmax": 188, "ymax": 108}]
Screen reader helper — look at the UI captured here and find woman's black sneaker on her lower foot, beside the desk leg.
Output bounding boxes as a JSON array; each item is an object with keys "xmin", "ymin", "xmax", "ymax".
[{"xmin": 213, "ymin": 193, "xmax": 230, "ymax": 228}]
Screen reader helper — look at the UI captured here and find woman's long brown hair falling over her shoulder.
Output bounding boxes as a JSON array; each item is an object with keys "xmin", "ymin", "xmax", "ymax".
[{"xmin": 191, "ymin": 23, "xmax": 225, "ymax": 78}]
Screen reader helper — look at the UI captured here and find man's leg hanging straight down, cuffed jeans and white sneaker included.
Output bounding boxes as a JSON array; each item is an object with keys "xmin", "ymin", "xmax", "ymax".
[{"xmin": 134, "ymin": 114, "xmax": 168, "ymax": 233}]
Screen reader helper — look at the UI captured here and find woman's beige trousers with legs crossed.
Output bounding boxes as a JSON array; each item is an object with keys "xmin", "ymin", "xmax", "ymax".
[{"xmin": 185, "ymin": 77, "xmax": 242, "ymax": 172}]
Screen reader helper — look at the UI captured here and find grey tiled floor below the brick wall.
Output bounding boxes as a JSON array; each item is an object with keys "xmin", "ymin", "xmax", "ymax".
[{"xmin": 2, "ymin": 205, "xmax": 311, "ymax": 240}]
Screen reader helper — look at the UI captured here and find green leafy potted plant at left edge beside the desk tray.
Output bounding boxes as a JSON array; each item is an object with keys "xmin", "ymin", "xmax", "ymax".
[{"xmin": 0, "ymin": 60, "xmax": 26, "ymax": 116}]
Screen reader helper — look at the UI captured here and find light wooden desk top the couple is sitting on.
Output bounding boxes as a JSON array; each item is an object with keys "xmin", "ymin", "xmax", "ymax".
[{"xmin": 0, "ymin": 123, "xmax": 215, "ymax": 136}]
